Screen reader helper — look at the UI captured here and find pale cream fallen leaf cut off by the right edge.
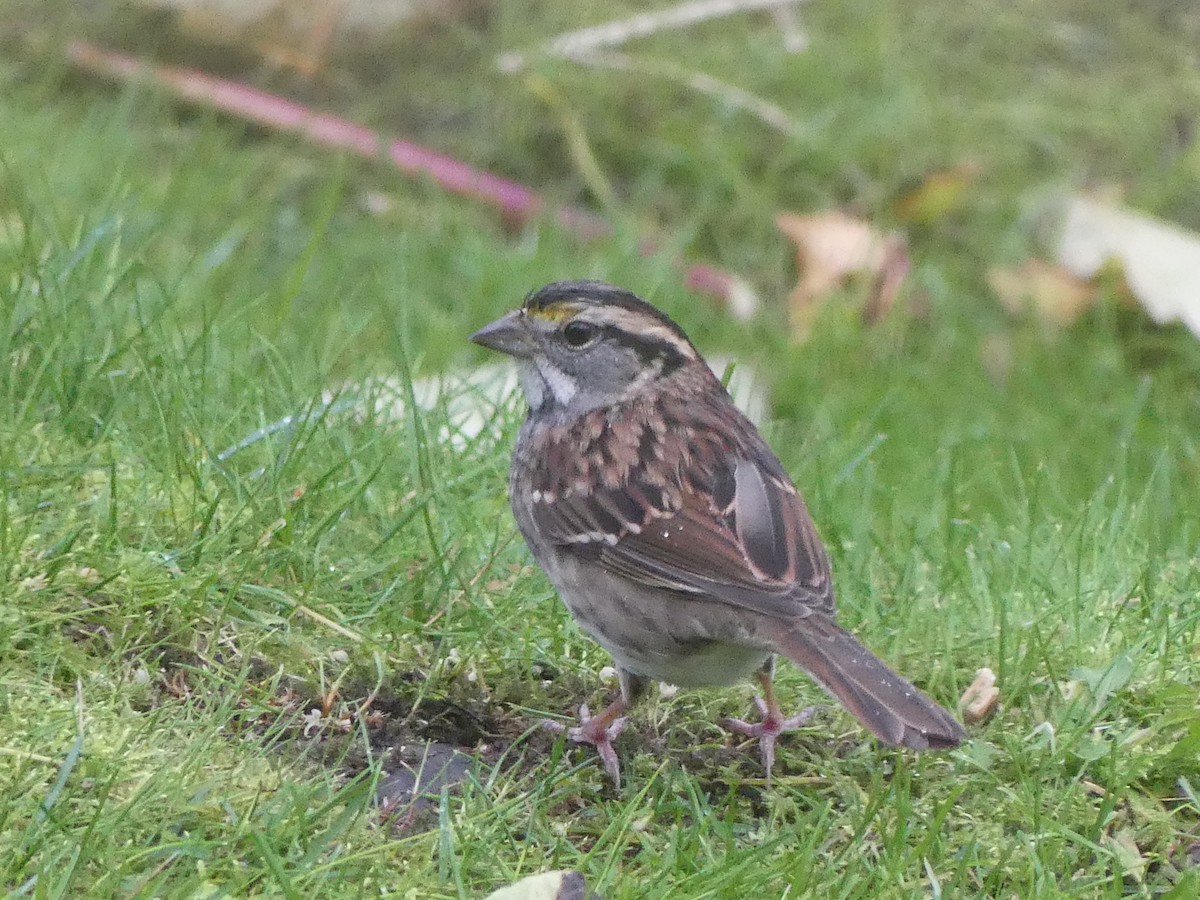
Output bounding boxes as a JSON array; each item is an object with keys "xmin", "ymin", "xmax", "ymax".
[{"xmin": 1058, "ymin": 197, "xmax": 1200, "ymax": 337}]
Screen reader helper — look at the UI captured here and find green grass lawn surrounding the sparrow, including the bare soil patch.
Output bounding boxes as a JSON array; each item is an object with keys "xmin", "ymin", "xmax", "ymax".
[{"xmin": 0, "ymin": 0, "xmax": 1200, "ymax": 900}]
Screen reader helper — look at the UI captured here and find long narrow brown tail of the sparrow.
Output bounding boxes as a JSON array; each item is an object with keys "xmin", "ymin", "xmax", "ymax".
[{"xmin": 775, "ymin": 614, "xmax": 966, "ymax": 750}]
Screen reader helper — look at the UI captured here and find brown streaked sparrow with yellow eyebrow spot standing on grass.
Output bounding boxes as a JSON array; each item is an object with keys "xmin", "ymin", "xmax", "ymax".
[{"xmin": 470, "ymin": 281, "xmax": 964, "ymax": 782}]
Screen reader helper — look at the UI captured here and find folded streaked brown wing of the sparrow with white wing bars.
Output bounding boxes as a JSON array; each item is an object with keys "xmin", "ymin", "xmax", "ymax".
[{"xmin": 529, "ymin": 400, "xmax": 834, "ymax": 618}]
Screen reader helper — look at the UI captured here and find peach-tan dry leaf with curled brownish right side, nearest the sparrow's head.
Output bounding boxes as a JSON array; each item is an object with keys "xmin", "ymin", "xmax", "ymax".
[{"xmin": 775, "ymin": 210, "xmax": 908, "ymax": 340}]
